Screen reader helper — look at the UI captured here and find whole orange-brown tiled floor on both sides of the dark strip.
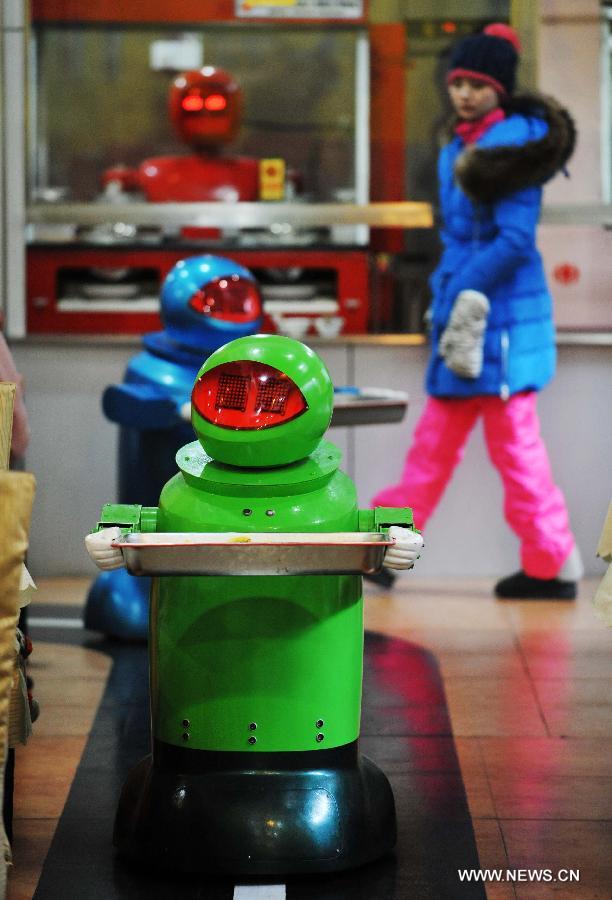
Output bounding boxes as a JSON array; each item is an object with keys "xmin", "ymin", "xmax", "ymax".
[{"xmin": 8, "ymin": 574, "xmax": 612, "ymax": 900}]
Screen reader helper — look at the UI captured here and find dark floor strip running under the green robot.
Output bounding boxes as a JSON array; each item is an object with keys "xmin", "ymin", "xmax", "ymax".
[{"xmin": 28, "ymin": 628, "xmax": 486, "ymax": 900}]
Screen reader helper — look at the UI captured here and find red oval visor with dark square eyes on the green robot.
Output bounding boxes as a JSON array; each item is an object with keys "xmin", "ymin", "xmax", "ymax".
[{"xmin": 191, "ymin": 360, "xmax": 308, "ymax": 430}]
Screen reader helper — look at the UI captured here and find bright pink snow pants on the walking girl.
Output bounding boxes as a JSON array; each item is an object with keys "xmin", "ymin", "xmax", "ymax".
[{"xmin": 372, "ymin": 391, "xmax": 574, "ymax": 578}]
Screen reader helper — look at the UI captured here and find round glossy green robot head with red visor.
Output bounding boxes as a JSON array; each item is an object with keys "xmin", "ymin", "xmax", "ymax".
[{"xmin": 191, "ymin": 334, "xmax": 334, "ymax": 468}]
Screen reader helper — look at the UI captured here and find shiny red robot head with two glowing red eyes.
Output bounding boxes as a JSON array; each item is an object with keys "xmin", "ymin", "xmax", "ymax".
[{"xmin": 169, "ymin": 66, "xmax": 242, "ymax": 148}]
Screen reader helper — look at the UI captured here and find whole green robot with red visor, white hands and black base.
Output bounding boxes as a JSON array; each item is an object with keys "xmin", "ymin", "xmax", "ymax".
[{"xmin": 86, "ymin": 335, "xmax": 422, "ymax": 875}]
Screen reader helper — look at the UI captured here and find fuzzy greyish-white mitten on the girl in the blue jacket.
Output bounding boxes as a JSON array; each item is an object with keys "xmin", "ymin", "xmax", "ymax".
[{"xmin": 438, "ymin": 291, "xmax": 490, "ymax": 378}]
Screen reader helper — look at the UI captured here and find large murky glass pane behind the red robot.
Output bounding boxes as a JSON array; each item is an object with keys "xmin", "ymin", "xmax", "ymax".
[{"xmin": 30, "ymin": 24, "xmax": 363, "ymax": 202}]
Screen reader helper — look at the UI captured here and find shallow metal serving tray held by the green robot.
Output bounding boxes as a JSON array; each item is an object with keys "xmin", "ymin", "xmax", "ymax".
[{"xmin": 113, "ymin": 531, "xmax": 394, "ymax": 575}]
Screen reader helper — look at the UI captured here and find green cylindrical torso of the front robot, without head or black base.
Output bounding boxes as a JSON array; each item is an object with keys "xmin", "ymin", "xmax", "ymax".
[{"xmin": 150, "ymin": 441, "xmax": 363, "ymax": 753}]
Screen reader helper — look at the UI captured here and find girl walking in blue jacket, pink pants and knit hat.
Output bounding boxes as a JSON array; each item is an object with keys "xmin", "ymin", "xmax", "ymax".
[{"xmin": 373, "ymin": 24, "xmax": 582, "ymax": 599}]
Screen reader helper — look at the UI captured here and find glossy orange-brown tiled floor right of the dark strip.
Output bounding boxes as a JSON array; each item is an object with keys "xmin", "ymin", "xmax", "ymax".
[{"xmin": 367, "ymin": 576, "xmax": 612, "ymax": 900}]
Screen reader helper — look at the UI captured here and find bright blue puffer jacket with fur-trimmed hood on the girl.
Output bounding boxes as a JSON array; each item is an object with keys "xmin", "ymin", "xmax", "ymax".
[{"xmin": 426, "ymin": 98, "xmax": 575, "ymax": 397}]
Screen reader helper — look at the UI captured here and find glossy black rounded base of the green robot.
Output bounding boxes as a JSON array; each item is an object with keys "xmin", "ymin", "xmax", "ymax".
[{"xmin": 114, "ymin": 741, "xmax": 396, "ymax": 875}]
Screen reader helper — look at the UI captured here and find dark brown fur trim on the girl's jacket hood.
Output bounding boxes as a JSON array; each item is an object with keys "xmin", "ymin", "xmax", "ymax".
[{"xmin": 455, "ymin": 94, "xmax": 576, "ymax": 203}]
